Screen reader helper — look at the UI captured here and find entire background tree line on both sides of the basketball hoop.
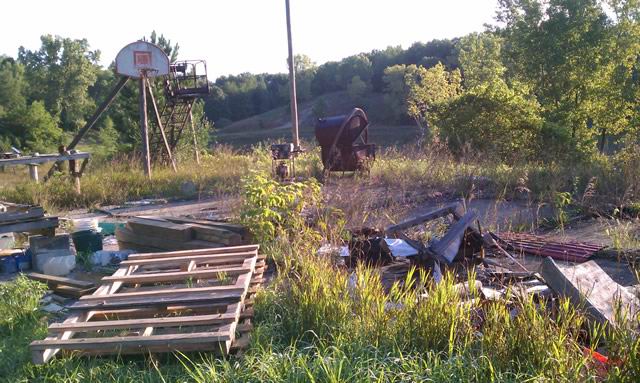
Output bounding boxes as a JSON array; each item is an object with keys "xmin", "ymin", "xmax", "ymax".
[{"xmin": 0, "ymin": 0, "xmax": 640, "ymax": 160}]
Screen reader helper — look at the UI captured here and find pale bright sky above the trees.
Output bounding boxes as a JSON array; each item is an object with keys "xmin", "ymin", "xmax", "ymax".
[{"xmin": 0, "ymin": 0, "xmax": 497, "ymax": 79}]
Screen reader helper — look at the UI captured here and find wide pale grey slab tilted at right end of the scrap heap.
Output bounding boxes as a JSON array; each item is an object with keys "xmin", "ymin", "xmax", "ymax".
[{"xmin": 540, "ymin": 257, "xmax": 640, "ymax": 325}]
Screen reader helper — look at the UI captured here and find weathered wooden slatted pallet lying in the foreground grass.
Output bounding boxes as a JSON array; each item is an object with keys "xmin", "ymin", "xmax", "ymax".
[{"xmin": 30, "ymin": 245, "xmax": 266, "ymax": 364}]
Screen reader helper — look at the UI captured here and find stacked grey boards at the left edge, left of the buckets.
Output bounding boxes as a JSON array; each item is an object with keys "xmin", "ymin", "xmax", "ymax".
[{"xmin": 0, "ymin": 201, "xmax": 58, "ymax": 234}]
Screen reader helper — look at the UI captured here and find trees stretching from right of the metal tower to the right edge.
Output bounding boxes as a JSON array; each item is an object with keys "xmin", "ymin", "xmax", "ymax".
[{"xmin": 205, "ymin": 0, "xmax": 640, "ymax": 159}]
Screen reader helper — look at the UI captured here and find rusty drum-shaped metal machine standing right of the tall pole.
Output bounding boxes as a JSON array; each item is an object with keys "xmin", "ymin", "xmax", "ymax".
[{"xmin": 315, "ymin": 108, "xmax": 376, "ymax": 172}]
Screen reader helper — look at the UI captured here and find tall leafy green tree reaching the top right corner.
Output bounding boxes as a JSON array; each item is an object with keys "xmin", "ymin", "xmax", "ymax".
[{"xmin": 496, "ymin": 0, "xmax": 639, "ymax": 154}]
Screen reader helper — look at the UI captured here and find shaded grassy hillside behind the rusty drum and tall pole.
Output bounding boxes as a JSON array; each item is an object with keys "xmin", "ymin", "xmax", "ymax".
[{"xmin": 217, "ymin": 91, "xmax": 418, "ymax": 147}]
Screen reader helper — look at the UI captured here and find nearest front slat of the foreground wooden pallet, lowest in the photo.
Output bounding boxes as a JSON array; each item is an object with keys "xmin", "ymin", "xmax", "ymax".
[{"xmin": 31, "ymin": 331, "xmax": 231, "ymax": 350}]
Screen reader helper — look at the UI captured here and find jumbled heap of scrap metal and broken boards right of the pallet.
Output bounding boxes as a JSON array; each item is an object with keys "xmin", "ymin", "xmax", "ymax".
[{"xmin": 342, "ymin": 203, "xmax": 640, "ymax": 332}]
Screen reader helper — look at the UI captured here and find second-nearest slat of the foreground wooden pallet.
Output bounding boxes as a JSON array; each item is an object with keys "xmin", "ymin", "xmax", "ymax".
[{"xmin": 49, "ymin": 313, "xmax": 235, "ymax": 333}]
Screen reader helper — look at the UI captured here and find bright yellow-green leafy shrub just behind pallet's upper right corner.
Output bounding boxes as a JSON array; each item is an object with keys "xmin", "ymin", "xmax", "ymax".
[{"xmin": 240, "ymin": 173, "xmax": 321, "ymax": 243}]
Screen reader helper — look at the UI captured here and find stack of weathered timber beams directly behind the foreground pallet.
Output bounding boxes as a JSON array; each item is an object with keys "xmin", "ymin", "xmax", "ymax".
[{"xmin": 116, "ymin": 216, "xmax": 251, "ymax": 252}]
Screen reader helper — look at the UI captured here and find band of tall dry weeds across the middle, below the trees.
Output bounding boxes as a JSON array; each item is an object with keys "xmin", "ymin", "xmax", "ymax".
[{"xmin": 0, "ymin": 144, "xmax": 640, "ymax": 215}]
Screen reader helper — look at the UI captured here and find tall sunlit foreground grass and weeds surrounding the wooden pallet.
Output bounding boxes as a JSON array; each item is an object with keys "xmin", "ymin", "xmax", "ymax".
[{"xmin": 0, "ymin": 175, "xmax": 640, "ymax": 383}]
